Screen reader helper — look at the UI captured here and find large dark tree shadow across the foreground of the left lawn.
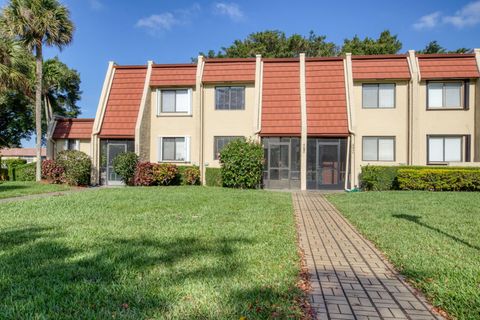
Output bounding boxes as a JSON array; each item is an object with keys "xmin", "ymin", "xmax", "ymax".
[{"xmin": 0, "ymin": 227, "xmax": 300, "ymax": 319}]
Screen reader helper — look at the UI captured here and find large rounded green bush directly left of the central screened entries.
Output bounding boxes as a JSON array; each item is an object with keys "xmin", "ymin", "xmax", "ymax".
[{"xmin": 220, "ymin": 139, "xmax": 263, "ymax": 188}]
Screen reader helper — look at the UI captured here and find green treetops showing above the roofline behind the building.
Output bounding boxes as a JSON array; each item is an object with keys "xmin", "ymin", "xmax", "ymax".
[{"xmin": 200, "ymin": 30, "xmax": 469, "ymax": 58}]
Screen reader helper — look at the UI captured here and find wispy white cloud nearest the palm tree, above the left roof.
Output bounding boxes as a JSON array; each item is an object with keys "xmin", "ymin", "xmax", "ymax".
[{"xmin": 136, "ymin": 4, "xmax": 201, "ymax": 34}]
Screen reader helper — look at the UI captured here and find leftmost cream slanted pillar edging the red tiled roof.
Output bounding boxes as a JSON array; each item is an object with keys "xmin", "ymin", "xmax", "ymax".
[{"xmin": 90, "ymin": 61, "xmax": 115, "ymax": 183}]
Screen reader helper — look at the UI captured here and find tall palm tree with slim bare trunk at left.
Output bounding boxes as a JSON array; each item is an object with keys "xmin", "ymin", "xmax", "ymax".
[{"xmin": 0, "ymin": 0, "xmax": 75, "ymax": 181}]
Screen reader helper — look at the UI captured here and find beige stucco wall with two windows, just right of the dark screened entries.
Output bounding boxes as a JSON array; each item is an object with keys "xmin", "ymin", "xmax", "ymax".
[{"xmin": 352, "ymin": 81, "xmax": 409, "ymax": 185}]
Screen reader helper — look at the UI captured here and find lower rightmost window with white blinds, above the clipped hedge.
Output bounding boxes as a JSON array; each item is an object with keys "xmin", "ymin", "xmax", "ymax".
[{"xmin": 427, "ymin": 136, "xmax": 469, "ymax": 163}]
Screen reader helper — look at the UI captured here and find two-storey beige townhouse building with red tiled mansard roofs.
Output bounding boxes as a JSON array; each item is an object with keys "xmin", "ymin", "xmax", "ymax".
[{"xmin": 48, "ymin": 49, "xmax": 480, "ymax": 190}]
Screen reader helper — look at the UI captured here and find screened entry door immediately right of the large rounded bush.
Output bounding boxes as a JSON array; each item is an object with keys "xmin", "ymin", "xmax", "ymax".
[{"xmin": 267, "ymin": 142, "xmax": 290, "ymax": 189}]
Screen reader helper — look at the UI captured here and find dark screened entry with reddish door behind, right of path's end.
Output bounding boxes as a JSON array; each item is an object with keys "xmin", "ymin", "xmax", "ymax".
[{"xmin": 307, "ymin": 138, "xmax": 347, "ymax": 189}]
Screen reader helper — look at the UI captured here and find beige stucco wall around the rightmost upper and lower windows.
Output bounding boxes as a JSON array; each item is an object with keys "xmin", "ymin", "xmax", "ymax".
[{"xmin": 412, "ymin": 80, "xmax": 478, "ymax": 165}]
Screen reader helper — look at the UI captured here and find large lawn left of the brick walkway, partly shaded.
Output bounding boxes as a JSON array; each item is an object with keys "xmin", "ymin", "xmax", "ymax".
[{"xmin": 0, "ymin": 187, "xmax": 302, "ymax": 319}]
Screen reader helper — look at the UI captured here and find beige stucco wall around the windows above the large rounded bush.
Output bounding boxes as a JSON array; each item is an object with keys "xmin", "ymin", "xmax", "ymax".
[{"xmin": 203, "ymin": 83, "xmax": 256, "ymax": 167}]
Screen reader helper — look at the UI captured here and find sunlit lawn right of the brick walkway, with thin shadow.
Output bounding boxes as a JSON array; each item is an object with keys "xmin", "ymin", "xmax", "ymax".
[{"xmin": 328, "ymin": 192, "xmax": 480, "ymax": 319}]
